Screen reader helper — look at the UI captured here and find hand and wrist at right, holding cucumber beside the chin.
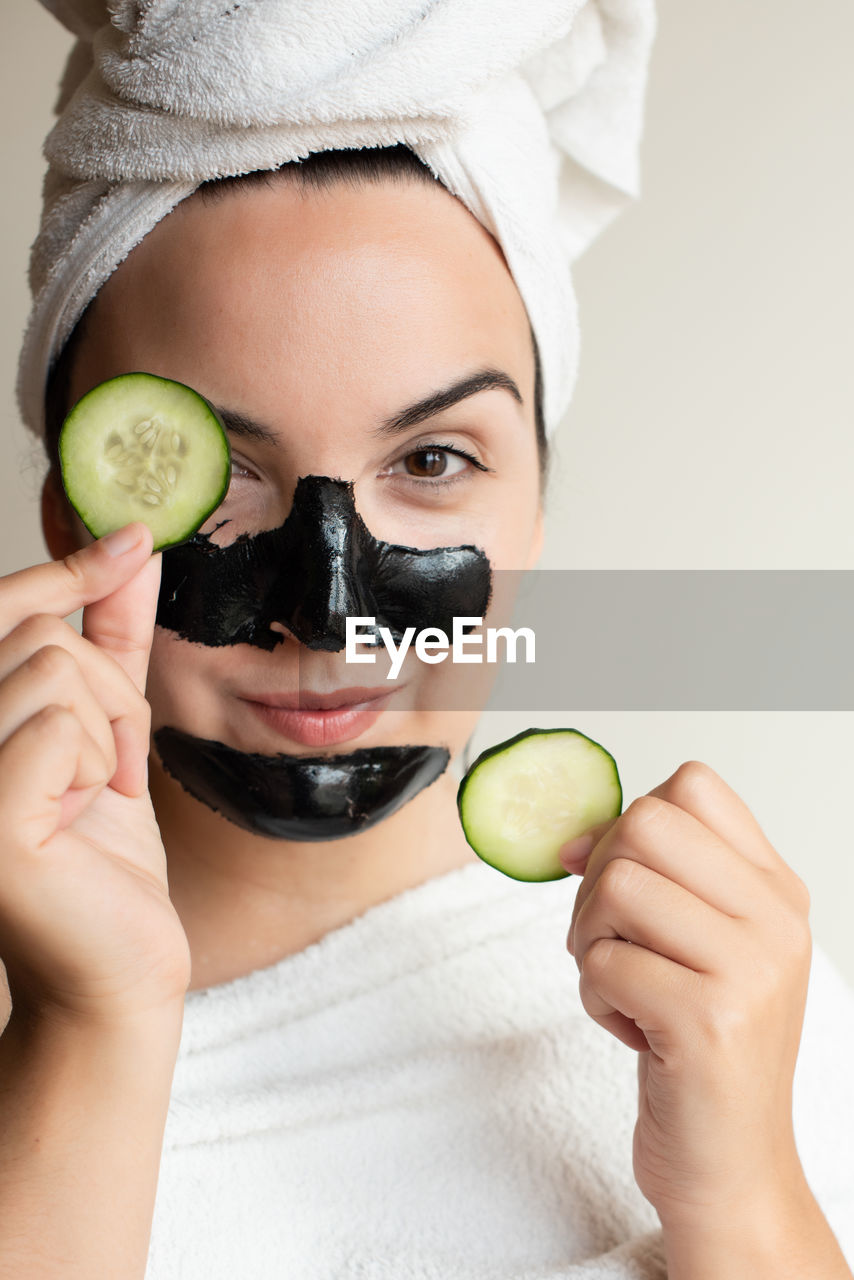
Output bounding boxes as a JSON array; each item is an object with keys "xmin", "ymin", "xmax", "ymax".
[{"xmin": 561, "ymin": 760, "xmax": 849, "ymax": 1277}]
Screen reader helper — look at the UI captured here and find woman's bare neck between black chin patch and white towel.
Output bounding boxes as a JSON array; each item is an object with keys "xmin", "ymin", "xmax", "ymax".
[{"xmin": 150, "ymin": 759, "xmax": 478, "ymax": 991}]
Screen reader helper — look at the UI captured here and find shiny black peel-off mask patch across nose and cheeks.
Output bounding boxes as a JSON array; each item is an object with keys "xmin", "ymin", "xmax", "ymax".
[{"xmin": 157, "ymin": 476, "xmax": 492, "ymax": 653}]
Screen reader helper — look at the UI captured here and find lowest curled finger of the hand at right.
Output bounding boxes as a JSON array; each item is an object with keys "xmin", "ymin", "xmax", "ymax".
[{"xmin": 579, "ymin": 938, "xmax": 703, "ymax": 1057}]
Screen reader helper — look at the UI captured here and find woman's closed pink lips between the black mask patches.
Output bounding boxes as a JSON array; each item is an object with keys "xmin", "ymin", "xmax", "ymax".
[{"xmin": 241, "ymin": 686, "xmax": 397, "ymax": 746}]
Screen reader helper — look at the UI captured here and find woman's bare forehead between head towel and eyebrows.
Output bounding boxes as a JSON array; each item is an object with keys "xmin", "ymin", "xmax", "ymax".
[{"xmin": 83, "ymin": 179, "xmax": 533, "ymax": 417}]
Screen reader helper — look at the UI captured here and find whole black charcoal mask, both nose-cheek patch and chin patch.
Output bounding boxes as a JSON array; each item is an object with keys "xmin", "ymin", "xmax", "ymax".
[{"xmin": 155, "ymin": 476, "xmax": 492, "ymax": 841}]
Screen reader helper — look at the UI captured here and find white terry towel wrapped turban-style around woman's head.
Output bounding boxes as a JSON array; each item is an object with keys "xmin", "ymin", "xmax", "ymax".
[{"xmin": 18, "ymin": 0, "xmax": 654, "ymax": 434}]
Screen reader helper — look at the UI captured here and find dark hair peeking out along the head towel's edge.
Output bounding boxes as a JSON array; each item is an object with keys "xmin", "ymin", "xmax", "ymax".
[{"xmin": 45, "ymin": 143, "xmax": 548, "ymax": 485}]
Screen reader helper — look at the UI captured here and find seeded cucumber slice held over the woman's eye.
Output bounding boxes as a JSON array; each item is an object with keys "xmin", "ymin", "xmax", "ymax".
[{"xmin": 59, "ymin": 374, "xmax": 232, "ymax": 550}]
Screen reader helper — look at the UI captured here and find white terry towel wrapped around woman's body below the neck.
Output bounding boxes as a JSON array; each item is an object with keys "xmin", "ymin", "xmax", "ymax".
[{"xmin": 146, "ymin": 863, "xmax": 854, "ymax": 1280}]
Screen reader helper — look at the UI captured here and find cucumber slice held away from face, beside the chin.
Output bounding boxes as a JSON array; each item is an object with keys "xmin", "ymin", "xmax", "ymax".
[{"xmin": 457, "ymin": 728, "xmax": 622, "ymax": 881}]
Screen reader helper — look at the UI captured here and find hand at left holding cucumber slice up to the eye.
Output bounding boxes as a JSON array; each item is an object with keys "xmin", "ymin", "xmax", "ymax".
[{"xmin": 0, "ymin": 524, "xmax": 189, "ymax": 1023}]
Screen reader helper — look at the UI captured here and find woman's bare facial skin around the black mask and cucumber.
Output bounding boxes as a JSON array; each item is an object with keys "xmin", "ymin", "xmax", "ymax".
[{"xmin": 70, "ymin": 178, "xmax": 542, "ymax": 783}]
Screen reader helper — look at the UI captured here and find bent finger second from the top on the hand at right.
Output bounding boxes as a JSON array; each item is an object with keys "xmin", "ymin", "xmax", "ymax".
[{"xmin": 572, "ymin": 796, "xmax": 768, "ymax": 942}]
